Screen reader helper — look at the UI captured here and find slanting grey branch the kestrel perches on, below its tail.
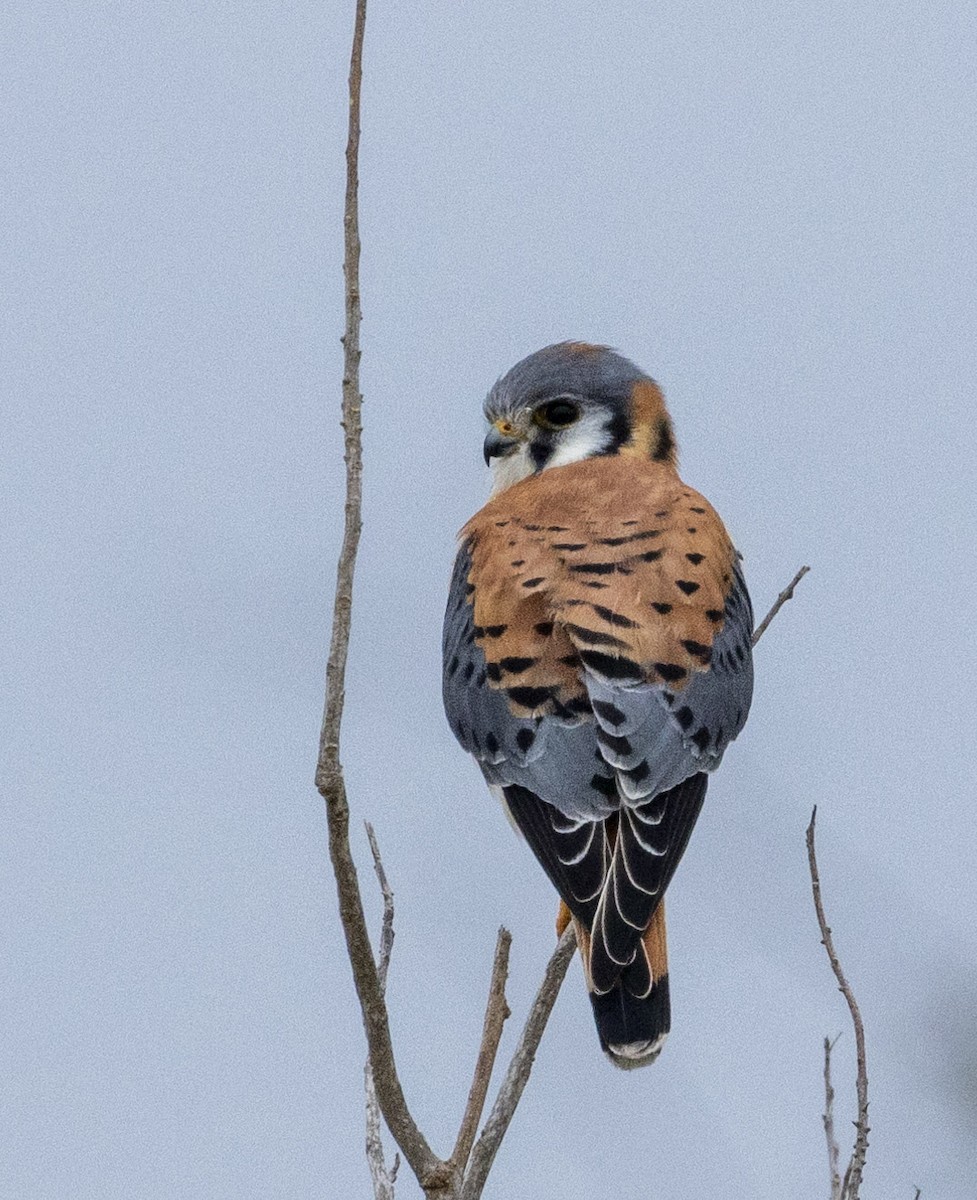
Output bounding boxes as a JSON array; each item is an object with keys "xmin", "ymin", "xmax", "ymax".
[{"xmin": 461, "ymin": 925, "xmax": 576, "ymax": 1200}]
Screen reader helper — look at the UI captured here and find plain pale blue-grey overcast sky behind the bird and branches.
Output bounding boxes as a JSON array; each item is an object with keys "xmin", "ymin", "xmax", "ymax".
[{"xmin": 0, "ymin": 0, "xmax": 977, "ymax": 1200}]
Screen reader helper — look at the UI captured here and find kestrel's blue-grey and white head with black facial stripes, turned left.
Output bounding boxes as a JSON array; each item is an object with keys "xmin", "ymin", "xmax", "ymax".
[{"xmin": 485, "ymin": 342, "xmax": 676, "ymax": 493}]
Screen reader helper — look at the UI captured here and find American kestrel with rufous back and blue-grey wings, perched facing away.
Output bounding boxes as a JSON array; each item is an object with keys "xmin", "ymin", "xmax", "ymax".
[{"xmin": 443, "ymin": 342, "xmax": 753, "ymax": 1068}]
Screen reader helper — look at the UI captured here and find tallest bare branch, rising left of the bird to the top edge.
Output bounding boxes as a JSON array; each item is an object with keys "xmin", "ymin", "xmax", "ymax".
[{"xmin": 316, "ymin": 0, "xmax": 446, "ymax": 1187}]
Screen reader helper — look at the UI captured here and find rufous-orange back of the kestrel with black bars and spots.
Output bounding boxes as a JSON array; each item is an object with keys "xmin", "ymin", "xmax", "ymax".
[{"xmin": 462, "ymin": 455, "xmax": 735, "ymax": 705}]
